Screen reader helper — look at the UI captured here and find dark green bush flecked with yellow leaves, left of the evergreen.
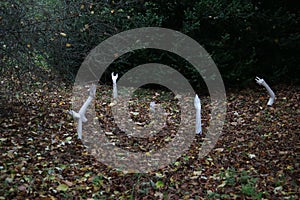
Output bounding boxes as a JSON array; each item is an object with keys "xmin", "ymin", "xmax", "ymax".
[{"xmin": 43, "ymin": 1, "xmax": 162, "ymax": 80}]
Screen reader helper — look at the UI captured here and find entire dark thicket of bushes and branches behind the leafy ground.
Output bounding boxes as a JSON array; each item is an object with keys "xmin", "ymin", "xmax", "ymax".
[{"xmin": 0, "ymin": 0, "xmax": 300, "ymax": 89}]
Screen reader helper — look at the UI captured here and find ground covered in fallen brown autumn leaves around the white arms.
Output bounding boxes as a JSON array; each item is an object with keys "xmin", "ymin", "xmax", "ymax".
[{"xmin": 0, "ymin": 77, "xmax": 300, "ymax": 200}]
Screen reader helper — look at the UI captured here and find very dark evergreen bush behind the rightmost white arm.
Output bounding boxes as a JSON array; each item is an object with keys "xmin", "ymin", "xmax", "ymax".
[{"xmin": 183, "ymin": 0, "xmax": 300, "ymax": 85}]
